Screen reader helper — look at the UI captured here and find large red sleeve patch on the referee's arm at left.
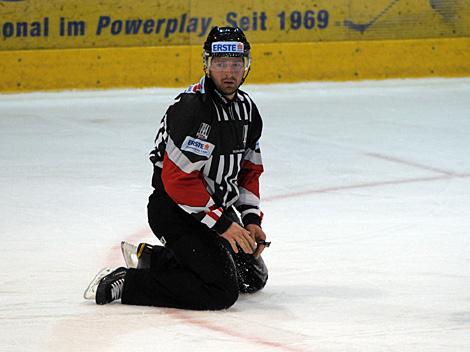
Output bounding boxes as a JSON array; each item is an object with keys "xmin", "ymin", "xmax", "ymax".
[{"xmin": 162, "ymin": 153, "xmax": 210, "ymax": 207}]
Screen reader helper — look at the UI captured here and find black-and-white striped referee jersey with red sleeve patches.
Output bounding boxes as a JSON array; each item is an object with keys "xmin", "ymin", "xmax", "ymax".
[{"xmin": 150, "ymin": 77, "xmax": 263, "ymax": 234}]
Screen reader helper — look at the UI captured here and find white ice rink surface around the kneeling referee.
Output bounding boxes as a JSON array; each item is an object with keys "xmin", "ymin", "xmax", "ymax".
[{"xmin": 0, "ymin": 79, "xmax": 470, "ymax": 352}]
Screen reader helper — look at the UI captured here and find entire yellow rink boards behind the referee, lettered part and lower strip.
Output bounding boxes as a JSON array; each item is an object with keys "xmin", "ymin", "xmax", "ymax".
[{"xmin": 0, "ymin": 0, "xmax": 470, "ymax": 92}]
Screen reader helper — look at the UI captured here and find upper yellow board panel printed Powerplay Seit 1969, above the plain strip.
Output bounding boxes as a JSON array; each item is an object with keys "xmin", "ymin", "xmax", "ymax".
[{"xmin": 0, "ymin": 0, "xmax": 470, "ymax": 50}]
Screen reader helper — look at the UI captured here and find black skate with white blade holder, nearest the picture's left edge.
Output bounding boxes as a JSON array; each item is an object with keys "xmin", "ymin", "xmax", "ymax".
[{"xmin": 83, "ymin": 267, "xmax": 127, "ymax": 304}]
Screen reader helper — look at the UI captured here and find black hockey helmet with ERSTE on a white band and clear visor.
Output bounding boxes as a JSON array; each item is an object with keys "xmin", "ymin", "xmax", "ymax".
[{"xmin": 203, "ymin": 26, "xmax": 251, "ymax": 79}]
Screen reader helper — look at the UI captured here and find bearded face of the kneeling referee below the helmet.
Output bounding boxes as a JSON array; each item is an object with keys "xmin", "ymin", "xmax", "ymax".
[{"xmin": 209, "ymin": 57, "xmax": 245, "ymax": 98}]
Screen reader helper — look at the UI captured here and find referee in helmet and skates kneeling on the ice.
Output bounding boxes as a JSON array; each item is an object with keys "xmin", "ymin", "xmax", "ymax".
[{"xmin": 85, "ymin": 27, "xmax": 270, "ymax": 310}]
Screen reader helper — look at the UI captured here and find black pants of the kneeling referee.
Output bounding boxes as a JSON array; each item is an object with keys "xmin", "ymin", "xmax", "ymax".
[{"xmin": 121, "ymin": 192, "xmax": 268, "ymax": 310}]
